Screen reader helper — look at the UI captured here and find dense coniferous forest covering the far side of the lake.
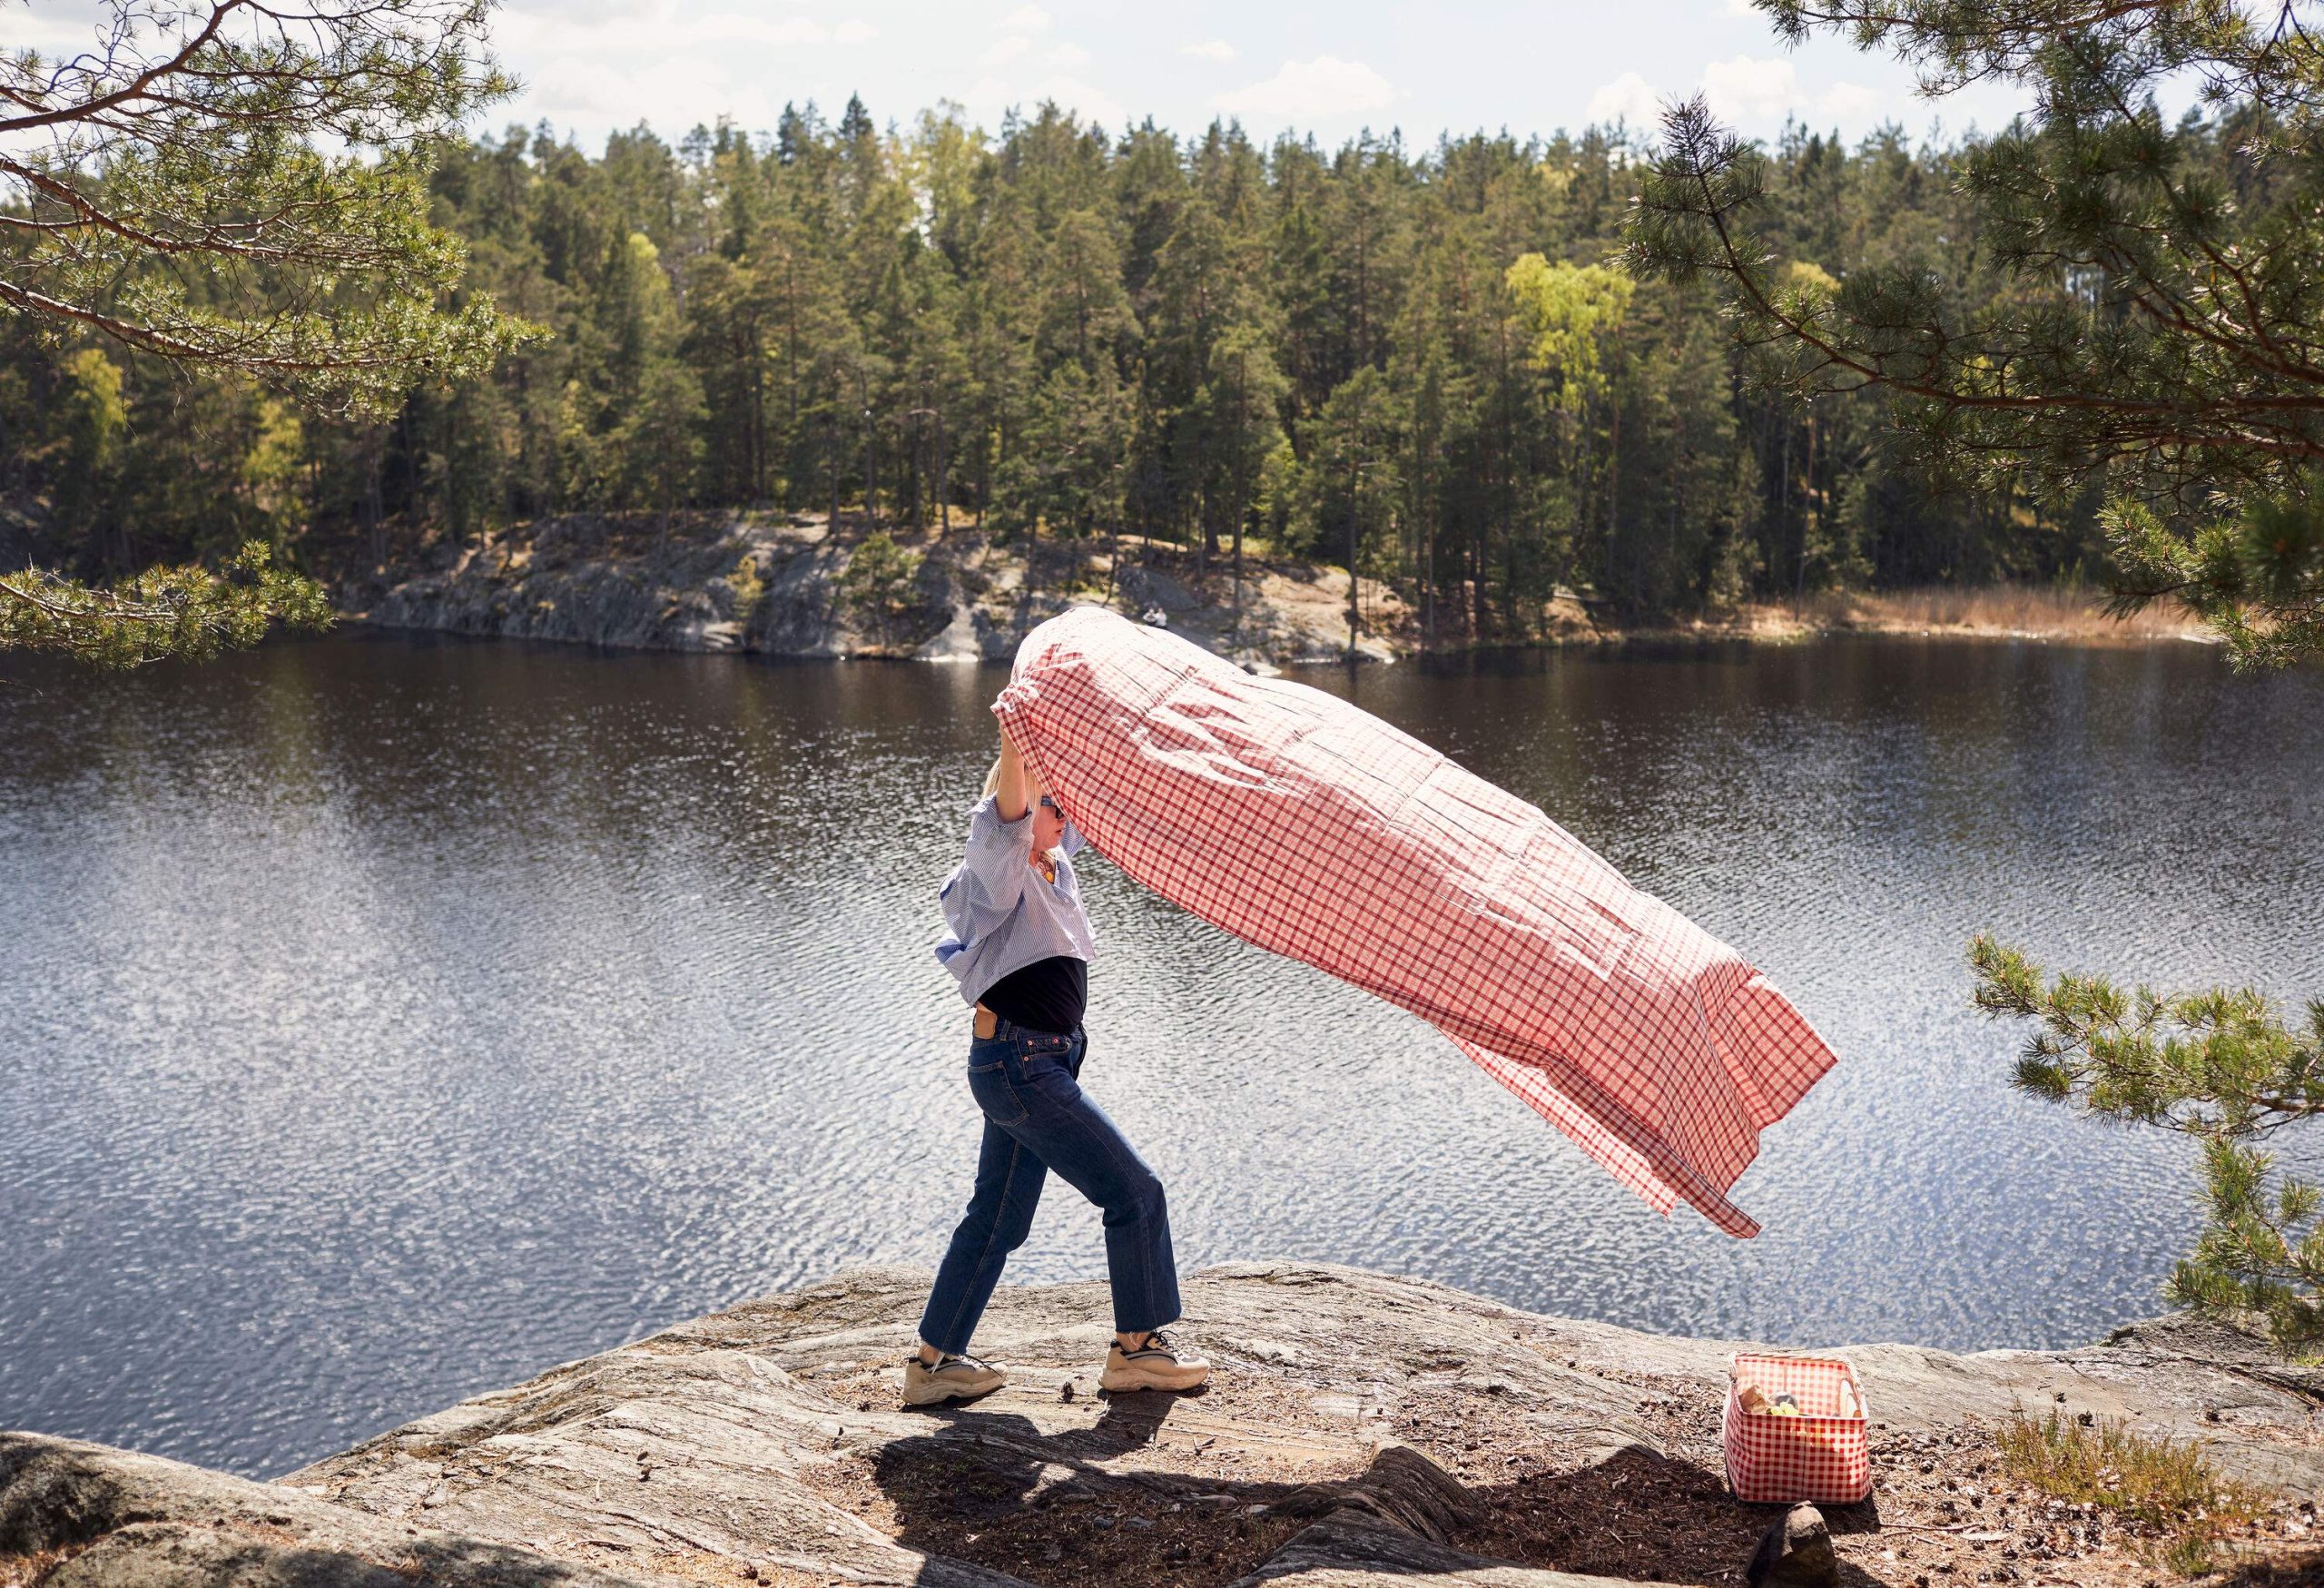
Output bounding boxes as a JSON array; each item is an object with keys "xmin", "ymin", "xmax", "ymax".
[{"xmin": 0, "ymin": 103, "xmax": 2128, "ymax": 644}]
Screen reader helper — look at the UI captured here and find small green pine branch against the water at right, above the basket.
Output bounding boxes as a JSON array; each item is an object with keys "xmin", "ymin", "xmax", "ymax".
[{"xmin": 1971, "ymin": 934, "xmax": 2324, "ymax": 1351}]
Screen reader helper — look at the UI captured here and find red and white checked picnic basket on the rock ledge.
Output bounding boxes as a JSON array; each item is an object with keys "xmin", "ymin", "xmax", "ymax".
[{"xmin": 1719, "ymin": 1353, "xmax": 1873, "ymax": 1504}]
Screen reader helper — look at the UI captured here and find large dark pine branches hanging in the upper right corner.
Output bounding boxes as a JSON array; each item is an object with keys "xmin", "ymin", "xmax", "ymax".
[{"xmin": 1624, "ymin": 0, "xmax": 2324, "ymax": 665}]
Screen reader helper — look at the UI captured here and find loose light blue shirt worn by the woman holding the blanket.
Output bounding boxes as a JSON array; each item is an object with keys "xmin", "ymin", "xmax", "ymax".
[{"xmin": 937, "ymin": 795, "xmax": 1097, "ymax": 1004}]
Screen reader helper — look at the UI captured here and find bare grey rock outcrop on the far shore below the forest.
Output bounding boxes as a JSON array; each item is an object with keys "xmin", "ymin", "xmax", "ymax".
[{"xmin": 340, "ymin": 516, "xmax": 1408, "ymax": 667}]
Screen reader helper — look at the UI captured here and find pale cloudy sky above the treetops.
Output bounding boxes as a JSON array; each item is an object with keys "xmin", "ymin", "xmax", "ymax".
[{"xmin": 486, "ymin": 0, "xmax": 2015, "ymax": 149}]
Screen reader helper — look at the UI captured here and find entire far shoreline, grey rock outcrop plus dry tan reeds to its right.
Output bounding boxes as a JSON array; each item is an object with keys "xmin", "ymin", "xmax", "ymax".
[{"xmin": 330, "ymin": 514, "xmax": 2217, "ymax": 672}]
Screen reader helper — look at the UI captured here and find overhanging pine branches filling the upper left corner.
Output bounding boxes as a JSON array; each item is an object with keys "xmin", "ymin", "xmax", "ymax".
[{"xmin": 0, "ymin": 0, "xmax": 539, "ymax": 665}]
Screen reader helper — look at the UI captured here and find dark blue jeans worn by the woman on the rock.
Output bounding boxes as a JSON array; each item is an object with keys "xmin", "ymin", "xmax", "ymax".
[{"xmin": 921, "ymin": 1021, "xmax": 1178, "ymax": 1356}]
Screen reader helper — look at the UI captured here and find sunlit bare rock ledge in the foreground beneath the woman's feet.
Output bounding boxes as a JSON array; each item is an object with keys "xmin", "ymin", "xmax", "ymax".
[{"xmin": 0, "ymin": 1262, "xmax": 2324, "ymax": 1588}]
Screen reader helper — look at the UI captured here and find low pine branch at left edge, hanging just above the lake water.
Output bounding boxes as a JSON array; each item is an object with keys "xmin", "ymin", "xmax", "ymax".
[{"xmin": 0, "ymin": 539, "xmax": 332, "ymax": 667}]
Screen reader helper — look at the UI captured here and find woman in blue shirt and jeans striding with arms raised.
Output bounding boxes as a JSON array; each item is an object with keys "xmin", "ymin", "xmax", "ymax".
[{"xmin": 904, "ymin": 733, "xmax": 1211, "ymax": 1406}]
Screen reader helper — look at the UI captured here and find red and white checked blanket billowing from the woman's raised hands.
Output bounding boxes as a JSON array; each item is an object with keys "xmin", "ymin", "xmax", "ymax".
[{"xmin": 992, "ymin": 607, "xmax": 1834, "ymax": 1237}]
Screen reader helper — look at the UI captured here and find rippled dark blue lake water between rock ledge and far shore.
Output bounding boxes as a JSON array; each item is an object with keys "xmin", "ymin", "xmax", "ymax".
[{"xmin": 0, "ymin": 635, "xmax": 2324, "ymax": 1475}]
